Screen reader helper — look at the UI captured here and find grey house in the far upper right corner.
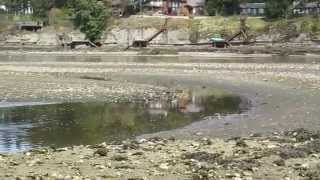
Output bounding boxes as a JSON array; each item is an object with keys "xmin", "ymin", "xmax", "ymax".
[{"xmin": 293, "ymin": 2, "xmax": 320, "ymax": 15}]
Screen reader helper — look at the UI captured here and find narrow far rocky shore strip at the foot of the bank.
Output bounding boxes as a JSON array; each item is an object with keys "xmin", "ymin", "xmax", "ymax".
[{"xmin": 0, "ymin": 43, "xmax": 320, "ymax": 56}]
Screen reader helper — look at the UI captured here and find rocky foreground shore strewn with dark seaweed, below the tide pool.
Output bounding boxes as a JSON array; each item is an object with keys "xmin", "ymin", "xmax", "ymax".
[{"xmin": 0, "ymin": 129, "xmax": 320, "ymax": 180}]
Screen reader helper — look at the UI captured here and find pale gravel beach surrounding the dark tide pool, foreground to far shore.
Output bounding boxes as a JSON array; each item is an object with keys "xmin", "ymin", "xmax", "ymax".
[{"xmin": 0, "ymin": 53, "xmax": 320, "ymax": 179}]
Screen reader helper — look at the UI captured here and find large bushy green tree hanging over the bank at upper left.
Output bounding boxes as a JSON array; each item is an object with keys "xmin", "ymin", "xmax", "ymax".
[{"xmin": 70, "ymin": 0, "xmax": 110, "ymax": 42}]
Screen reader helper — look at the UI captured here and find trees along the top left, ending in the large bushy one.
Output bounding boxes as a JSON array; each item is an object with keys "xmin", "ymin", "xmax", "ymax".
[{"xmin": 0, "ymin": 0, "xmax": 110, "ymax": 42}]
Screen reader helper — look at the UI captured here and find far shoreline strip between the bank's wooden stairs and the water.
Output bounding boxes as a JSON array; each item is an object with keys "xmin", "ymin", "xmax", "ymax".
[{"xmin": 0, "ymin": 43, "xmax": 320, "ymax": 58}]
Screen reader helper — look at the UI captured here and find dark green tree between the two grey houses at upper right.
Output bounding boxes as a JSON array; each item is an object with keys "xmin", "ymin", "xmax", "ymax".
[{"xmin": 266, "ymin": 0, "xmax": 293, "ymax": 19}]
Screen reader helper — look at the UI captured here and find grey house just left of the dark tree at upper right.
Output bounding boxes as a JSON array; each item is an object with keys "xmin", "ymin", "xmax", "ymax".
[{"xmin": 240, "ymin": 3, "xmax": 266, "ymax": 16}]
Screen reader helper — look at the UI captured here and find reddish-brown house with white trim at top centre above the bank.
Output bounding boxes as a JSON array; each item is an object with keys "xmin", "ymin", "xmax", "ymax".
[{"xmin": 144, "ymin": 0, "xmax": 204, "ymax": 16}]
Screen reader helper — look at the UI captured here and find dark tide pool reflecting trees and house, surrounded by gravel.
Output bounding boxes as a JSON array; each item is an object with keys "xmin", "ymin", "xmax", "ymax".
[{"xmin": 0, "ymin": 94, "xmax": 243, "ymax": 152}]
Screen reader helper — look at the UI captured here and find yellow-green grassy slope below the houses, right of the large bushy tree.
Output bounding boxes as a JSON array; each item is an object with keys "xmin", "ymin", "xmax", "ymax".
[{"xmin": 109, "ymin": 16, "xmax": 320, "ymax": 38}]
